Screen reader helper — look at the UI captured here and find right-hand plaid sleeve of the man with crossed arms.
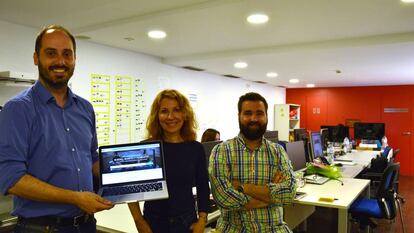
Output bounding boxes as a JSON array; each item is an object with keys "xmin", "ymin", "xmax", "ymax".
[{"xmin": 269, "ymin": 144, "xmax": 296, "ymax": 205}]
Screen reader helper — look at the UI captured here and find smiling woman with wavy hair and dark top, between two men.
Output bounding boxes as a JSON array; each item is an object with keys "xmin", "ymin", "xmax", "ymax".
[{"xmin": 129, "ymin": 89, "xmax": 210, "ymax": 233}]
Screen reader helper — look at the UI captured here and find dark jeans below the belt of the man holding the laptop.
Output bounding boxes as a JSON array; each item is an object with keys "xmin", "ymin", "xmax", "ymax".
[{"xmin": 14, "ymin": 219, "xmax": 96, "ymax": 233}]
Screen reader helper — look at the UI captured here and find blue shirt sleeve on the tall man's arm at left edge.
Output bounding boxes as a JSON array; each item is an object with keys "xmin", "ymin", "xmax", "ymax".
[{"xmin": 0, "ymin": 101, "xmax": 30, "ymax": 195}]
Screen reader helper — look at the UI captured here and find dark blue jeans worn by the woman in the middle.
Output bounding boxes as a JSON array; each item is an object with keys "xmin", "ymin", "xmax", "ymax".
[{"xmin": 144, "ymin": 211, "xmax": 197, "ymax": 233}]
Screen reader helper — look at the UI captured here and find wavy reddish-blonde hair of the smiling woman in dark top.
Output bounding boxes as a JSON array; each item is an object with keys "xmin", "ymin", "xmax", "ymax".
[{"xmin": 147, "ymin": 89, "xmax": 198, "ymax": 142}]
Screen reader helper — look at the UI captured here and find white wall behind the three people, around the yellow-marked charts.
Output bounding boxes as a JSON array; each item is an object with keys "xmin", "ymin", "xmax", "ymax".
[{"xmin": 0, "ymin": 21, "xmax": 285, "ymax": 139}]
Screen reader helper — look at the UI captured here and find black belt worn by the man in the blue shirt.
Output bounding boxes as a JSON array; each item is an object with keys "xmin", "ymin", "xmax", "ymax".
[{"xmin": 17, "ymin": 214, "xmax": 94, "ymax": 227}]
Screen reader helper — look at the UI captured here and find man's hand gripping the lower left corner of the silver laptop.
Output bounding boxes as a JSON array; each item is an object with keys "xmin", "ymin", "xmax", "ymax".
[{"xmin": 73, "ymin": 192, "xmax": 114, "ymax": 214}]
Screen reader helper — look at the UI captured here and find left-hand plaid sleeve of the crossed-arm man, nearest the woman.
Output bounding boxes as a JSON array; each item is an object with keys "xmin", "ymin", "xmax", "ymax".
[{"xmin": 209, "ymin": 143, "xmax": 250, "ymax": 210}]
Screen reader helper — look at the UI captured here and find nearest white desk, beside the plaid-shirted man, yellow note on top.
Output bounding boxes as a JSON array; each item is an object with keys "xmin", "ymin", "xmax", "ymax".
[{"xmin": 294, "ymin": 178, "xmax": 370, "ymax": 233}]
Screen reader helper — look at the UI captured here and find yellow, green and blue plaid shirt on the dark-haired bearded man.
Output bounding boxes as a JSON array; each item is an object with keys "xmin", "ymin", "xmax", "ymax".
[{"xmin": 209, "ymin": 135, "xmax": 296, "ymax": 233}]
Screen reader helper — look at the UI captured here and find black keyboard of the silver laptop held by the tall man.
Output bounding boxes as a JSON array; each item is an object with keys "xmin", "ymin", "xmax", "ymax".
[{"xmin": 102, "ymin": 182, "xmax": 162, "ymax": 196}]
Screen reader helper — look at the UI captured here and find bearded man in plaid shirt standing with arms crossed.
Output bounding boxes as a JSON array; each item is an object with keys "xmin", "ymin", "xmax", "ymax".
[{"xmin": 209, "ymin": 92, "xmax": 296, "ymax": 233}]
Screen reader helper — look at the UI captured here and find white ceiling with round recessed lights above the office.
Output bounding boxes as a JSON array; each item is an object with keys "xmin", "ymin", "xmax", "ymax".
[{"xmin": 0, "ymin": 0, "xmax": 414, "ymax": 87}]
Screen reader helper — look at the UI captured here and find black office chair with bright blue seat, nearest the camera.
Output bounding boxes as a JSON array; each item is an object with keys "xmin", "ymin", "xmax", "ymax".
[{"xmin": 349, "ymin": 163, "xmax": 405, "ymax": 233}]
